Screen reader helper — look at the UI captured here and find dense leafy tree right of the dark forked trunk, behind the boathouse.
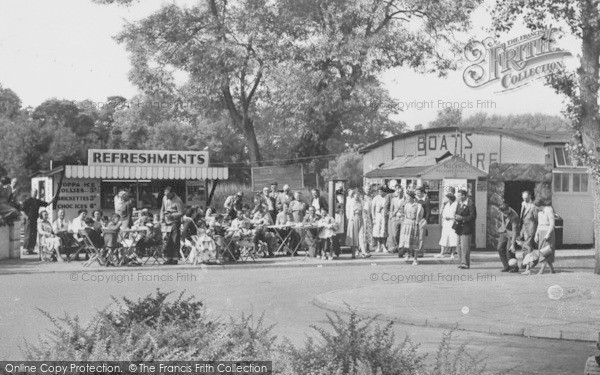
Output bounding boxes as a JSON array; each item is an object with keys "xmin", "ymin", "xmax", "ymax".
[{"xmin": 270, "ymin": 0, "xmax": 478, "ymax": 161}]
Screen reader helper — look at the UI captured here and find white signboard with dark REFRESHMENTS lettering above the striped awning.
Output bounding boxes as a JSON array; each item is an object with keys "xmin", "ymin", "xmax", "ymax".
[{"xmin": 88, "ymin": 149, "xmax": 208, "ymax": 167}]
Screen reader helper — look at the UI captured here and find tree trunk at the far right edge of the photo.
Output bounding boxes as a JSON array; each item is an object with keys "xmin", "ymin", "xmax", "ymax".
[{"xmin": 578, "ymin": 0, "xmax": 600, "ymax": 274}]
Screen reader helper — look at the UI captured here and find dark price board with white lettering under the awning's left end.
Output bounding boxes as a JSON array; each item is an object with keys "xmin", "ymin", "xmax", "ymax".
[{"xmin": 56, "ymin": 179, "xmax": 100, "ymax": 220}]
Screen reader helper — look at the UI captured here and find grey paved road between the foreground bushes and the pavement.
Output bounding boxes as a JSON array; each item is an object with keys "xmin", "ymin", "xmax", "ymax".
[{"xmin": 0, "ymin": 260, "xmax": 594, "ymax": 374}]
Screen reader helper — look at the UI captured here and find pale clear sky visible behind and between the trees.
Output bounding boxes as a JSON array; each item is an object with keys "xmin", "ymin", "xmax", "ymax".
[{"xmin": 0, "ymin": 0, "xmax": 577, "ymax": 127}]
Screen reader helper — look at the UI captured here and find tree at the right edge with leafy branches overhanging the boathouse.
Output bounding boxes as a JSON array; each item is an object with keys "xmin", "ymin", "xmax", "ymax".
[{"xmin": 493, "ymin": 0, "xmax": 600, "ymax": 274}]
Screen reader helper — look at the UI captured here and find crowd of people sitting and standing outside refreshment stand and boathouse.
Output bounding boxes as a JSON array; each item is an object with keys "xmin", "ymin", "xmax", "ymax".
[{"xmin": 0, "ymin": 177, "xmax": 555, "ymax": 274}]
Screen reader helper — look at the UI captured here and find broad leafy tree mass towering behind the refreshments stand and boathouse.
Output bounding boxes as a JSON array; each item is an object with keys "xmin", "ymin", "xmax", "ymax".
[{"xmin": 95, "ymin": 0, "xmax": 480, "ymax": 164}]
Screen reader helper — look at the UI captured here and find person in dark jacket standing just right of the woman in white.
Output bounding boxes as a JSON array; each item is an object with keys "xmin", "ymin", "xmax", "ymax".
[{"xmin": 454, "ymin": 189, "xmax": 477, "ymax": 269}]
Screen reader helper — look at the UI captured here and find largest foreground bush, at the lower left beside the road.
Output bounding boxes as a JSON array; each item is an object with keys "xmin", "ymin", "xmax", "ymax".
[{"xmin": 23, "ymin": 291, "xmax": 275, "ymax": 361}]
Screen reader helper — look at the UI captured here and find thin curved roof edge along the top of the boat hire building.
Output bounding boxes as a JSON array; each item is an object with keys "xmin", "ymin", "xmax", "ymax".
[{"xmin": 359, "ymin": 126, "xmax": 573, "ymax": 154}]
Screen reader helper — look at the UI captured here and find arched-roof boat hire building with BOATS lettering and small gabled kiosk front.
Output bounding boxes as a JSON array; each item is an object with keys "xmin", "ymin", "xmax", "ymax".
[{"xmin": 360, "ymin": 127, "xmax": 594, "ymax": 253}]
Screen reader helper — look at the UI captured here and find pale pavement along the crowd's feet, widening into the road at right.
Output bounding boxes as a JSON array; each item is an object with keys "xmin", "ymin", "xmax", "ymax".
[{"xmin": 0, "ymin": 249, "xmax": 600, "ymax": 342}]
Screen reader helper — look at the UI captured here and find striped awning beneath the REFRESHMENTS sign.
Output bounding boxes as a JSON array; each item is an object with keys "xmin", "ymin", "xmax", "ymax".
[{"xmin": 65, "ymin": 165, "xmax": 229, "ymax": 180}]
